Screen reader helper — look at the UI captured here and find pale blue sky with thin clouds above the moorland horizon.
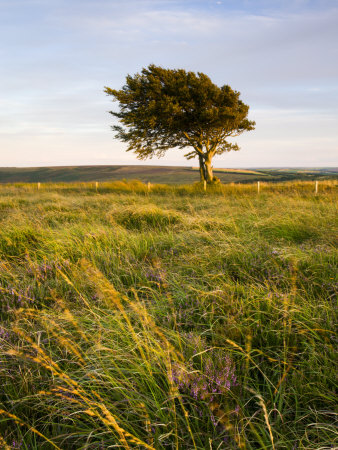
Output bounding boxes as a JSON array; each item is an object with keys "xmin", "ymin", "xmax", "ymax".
[{"xmin": 0, "ymin": 0, "xmax": 338, "ymax": 167}]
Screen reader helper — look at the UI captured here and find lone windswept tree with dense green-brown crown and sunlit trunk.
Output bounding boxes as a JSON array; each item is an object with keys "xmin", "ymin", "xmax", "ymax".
[{"xmin": 104, "ymin": 65, "xmax": 255, "ymax": 183}]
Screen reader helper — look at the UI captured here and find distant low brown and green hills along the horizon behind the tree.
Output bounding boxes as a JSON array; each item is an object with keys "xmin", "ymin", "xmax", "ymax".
[{"xmin": 0, "ymin": 165, "xmax": 338, "ymax": 184}]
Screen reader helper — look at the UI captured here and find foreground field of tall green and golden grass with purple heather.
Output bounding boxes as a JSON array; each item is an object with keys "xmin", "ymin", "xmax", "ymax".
[{"xmin": 0, "ymin": 179, "xmax": 338, "ymax": 450}]
